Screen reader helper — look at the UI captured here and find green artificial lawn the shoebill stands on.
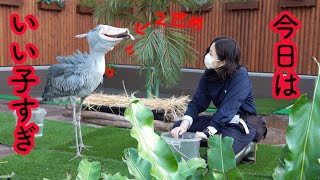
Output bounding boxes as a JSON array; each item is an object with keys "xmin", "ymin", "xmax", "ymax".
[{"xmin": 0, "ymin": 113, "xmax": 281, "ymax": 180}]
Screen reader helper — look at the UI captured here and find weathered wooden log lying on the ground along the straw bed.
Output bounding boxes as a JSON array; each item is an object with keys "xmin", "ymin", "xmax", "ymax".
[{"xmin": 62, "ymin": 111, "xmax": 173, "ymax": 131}]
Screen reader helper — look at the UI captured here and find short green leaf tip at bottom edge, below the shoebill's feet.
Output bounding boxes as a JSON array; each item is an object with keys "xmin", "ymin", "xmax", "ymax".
[{"xmin": 77, "ymin": 159, "xmax": 101, "ymax": 180}]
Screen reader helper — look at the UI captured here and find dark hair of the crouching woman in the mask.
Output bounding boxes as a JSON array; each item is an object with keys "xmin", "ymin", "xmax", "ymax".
[{"xmin": 205, "ymin": 37, "xmax": 240, "ymax": 80}]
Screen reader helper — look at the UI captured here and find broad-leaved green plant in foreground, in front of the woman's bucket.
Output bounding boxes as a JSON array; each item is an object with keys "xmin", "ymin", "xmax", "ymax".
[{"xmin": 72, "ymin": 97, "xmax": 242, "ymax": 180}]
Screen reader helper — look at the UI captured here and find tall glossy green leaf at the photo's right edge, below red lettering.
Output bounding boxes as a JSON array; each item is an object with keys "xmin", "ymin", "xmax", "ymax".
[{"xmin": 284, "ymin": 58, "xmax": 320, "ymax": 179}]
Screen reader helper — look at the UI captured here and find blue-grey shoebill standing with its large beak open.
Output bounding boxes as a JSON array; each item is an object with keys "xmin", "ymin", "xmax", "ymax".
[{"xmin": 42, "ymin": 25, "xmax": 134, "ymax": 158}]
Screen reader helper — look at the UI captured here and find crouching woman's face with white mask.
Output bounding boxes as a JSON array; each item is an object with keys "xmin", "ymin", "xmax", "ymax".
[{"xmin": 204, "ymin": 43, "xmax": 225, "ymax": 69}]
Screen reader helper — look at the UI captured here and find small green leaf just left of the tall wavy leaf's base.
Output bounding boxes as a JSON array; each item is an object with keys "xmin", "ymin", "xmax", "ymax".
[{"xmin": 123, "ymin": 148, "xmax": 152, "ymax": 180}]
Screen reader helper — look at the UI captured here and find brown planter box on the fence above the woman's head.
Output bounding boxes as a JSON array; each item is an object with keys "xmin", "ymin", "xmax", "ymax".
[{"xmin": 226, "ymin": 0, "xmax": 259, "ymax": 10}]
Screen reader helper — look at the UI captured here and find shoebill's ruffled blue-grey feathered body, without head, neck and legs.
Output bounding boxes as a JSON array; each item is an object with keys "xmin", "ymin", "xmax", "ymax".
[{"xmin": 42, "ymin": 51, "xmax": 103, "ymax": 99}]
